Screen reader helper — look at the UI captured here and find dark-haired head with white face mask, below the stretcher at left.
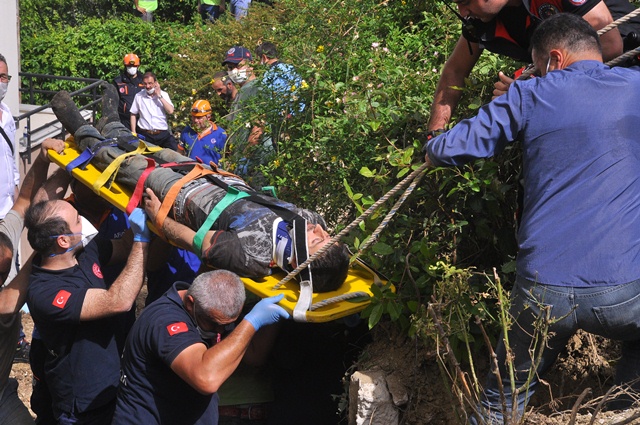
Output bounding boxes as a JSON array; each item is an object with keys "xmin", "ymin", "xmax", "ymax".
[{"xmin": 24, "ymin": 201, "xmax": 98, "ymax": 257}]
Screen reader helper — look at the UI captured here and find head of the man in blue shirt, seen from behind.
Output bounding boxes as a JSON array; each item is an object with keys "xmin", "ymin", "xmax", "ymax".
[{"xmin": 531, "ymin": 13, "xmax": 602, "ymax": 75}]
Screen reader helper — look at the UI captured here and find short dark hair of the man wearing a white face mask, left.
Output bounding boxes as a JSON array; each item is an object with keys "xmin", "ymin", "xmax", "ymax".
[{"xmin": 24, "ymin": 201, "xmax": 71, "ymax": 255}]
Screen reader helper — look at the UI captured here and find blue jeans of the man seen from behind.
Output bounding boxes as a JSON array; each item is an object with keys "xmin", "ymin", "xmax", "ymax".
[{"xmin": 471, "ymin": 277, "xmax": 640, "ymax": 424}]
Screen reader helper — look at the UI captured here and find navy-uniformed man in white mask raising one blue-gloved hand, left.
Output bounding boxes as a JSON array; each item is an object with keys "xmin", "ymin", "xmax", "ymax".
[{"xmin": 25, "ymin": 201, "xmax": 150, "ymax": 424}]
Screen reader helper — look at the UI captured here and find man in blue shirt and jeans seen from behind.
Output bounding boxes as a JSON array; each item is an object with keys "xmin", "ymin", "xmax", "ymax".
[{"xmin": 425, "ymin": 14, "xmax": 640, "ymax": 423}]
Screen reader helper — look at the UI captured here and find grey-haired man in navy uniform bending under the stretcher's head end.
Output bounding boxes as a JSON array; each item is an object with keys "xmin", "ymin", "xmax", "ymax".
[{"xmin": 113, "ymin": 270, "xmax": 289, "ymax": 425}]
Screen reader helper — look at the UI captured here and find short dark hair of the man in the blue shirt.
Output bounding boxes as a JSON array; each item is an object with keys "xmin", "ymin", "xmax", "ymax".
[{"xmin": 531, "ymin": 13, "xmax": 602, "ymax": 59}]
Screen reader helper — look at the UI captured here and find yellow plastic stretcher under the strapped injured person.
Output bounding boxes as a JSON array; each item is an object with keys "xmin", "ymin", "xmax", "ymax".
[{"xmin": 48, "ymin": 139, "xmax": 393, "ymax": 322}]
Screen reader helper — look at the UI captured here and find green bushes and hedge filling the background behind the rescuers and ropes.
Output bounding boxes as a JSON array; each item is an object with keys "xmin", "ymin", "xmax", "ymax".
[{"xmin": 20, "ymin": 0, "xmax": 520, "ymax": 350}]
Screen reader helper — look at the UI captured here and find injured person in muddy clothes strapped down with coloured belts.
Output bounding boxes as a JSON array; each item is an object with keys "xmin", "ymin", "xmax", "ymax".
[{"xmin": 51, "ymin": 85, "xmax": 349, "ymax": 292}]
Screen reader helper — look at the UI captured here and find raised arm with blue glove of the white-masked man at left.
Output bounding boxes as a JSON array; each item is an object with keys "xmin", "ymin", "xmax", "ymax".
[{"xmin": 80, "ymin": 208, "xmax": 151, "ymax": 321}]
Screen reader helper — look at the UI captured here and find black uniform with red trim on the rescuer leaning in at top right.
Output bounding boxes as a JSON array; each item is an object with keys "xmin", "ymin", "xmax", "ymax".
[{"xmin": 462, "ymin": 0, "xmax": 640, "ymax": 62}]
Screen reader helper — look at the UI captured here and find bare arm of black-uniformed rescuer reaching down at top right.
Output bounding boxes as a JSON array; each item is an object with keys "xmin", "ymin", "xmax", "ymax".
[{"xmin": 427, "ymin": 36, "xmax": 482, "ymax": 130}]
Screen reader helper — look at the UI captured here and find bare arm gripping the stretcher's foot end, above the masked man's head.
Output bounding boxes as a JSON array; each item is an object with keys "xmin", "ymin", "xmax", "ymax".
[{"xmin": 11, "ymin": 139, "xmax": 64, "ymax": 217}]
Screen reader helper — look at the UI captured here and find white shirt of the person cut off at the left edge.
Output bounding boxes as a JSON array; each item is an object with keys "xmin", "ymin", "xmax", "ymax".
[{"xmin": 0, "ymin": 102, "xmax": 20, "ymax": 218}]
